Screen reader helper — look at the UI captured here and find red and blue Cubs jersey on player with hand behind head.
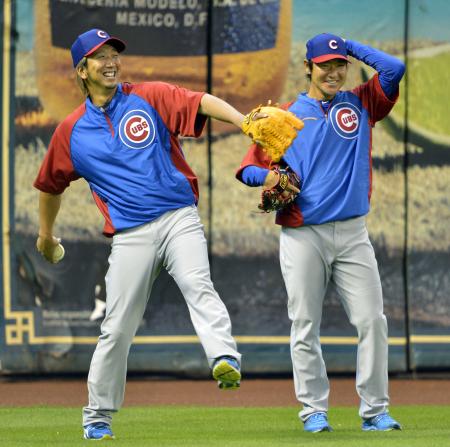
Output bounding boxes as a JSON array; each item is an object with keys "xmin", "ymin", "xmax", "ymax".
[{"xmin": 237, "ymin": 74, "xmax": 398, "ymax": 227}]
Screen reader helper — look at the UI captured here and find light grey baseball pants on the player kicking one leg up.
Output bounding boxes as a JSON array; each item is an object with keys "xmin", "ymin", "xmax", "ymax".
[{"xmin": 83, "ymin": 206, "xmax": 241, "ymax": 426}]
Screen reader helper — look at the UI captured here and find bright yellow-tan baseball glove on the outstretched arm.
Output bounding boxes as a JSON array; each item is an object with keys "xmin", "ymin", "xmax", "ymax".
[{"xmin": 242, "ymin": 102, "xmax": 304, "ymax": 162}]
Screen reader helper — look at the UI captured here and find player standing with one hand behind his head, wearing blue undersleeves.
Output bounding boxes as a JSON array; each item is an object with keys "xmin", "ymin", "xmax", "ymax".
[{"xmin": 237, "ymin": 33, "xmax": 405, "ymax": 432}]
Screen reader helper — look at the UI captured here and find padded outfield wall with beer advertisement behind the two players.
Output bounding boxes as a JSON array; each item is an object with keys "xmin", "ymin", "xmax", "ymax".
[{"xmin": 0, "ymin": 0, "xmax": 450, "ymax": 377}]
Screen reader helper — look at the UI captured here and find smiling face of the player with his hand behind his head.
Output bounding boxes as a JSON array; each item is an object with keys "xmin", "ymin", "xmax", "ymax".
[{"xmin": 305, "ymin": 59, "xmax": 348, "ymax": 101}]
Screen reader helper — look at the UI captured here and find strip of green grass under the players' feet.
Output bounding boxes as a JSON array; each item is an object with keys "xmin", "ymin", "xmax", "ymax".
[{"xmin": 0, "ymin": 406, "xmax": 450, "ymax": 447}]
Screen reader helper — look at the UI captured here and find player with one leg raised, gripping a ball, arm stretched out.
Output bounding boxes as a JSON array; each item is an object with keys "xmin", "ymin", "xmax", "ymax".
[{"xmin": 34, "ymin": 29, "xmax": 253, "ymax": 440}]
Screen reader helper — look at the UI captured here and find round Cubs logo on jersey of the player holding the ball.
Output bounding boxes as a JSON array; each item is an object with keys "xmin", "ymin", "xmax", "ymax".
[{"xmin": 119, "ymin": 110, "xmax": 155, "ymax": 149}]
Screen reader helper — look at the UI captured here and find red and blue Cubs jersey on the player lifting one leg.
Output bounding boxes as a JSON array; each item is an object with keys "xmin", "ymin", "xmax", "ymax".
[{"xmin": 34, "ymin": 82, "xmax": 206, "ymax": 236}]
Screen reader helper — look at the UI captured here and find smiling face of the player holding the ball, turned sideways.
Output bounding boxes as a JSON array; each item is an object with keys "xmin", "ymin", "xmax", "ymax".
[{"xmin": 78, "ymin": 44, "xmax": 121, "ymax": 103}]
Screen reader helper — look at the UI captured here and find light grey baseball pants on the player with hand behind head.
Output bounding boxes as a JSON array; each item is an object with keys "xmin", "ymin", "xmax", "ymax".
[{"xmin": 280, "ymin": 217, "xmax": 389, "ymax": 421}]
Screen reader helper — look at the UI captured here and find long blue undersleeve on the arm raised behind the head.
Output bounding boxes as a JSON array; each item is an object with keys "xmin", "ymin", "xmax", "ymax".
[{"xmin": 345, "ymin": 40, "xmax": 405, "ymax": 99}]
